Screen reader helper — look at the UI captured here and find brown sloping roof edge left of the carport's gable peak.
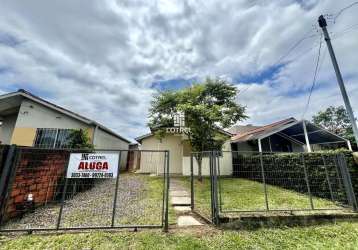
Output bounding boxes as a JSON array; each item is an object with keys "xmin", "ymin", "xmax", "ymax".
[{"xmin": 231, "ymin": 117, "xmax": 297, "ymax": 142}]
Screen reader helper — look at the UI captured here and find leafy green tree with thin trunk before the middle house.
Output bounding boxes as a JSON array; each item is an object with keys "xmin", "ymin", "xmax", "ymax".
[{"xmin": 148, "ymin": 78, "xmax": 247, "ymax": 180}]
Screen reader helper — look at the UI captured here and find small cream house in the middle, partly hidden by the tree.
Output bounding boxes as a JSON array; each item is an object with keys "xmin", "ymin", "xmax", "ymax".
[{"xmin": 136, "ymin": 130, "xmax": 232, "ymax": 175}]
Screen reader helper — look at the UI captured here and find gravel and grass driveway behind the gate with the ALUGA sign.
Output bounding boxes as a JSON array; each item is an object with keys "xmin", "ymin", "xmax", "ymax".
[{"xmin": 3, "ymin": 174, "xmax": 172, "ymax": 229}]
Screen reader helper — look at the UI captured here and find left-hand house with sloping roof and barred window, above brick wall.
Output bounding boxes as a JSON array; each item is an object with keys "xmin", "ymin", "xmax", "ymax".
[{"xmin": 0, "ymin": 90, "xmax": 130, "ymax": 149}]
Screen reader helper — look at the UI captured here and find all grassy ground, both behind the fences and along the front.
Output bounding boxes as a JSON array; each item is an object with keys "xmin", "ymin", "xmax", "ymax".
[{"xmin": 0, "ymin": 174, "xmax": 358, "ymax": 249}]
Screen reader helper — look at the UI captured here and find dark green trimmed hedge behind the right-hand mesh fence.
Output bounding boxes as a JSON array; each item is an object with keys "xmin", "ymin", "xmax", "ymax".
[{"xmin": 233, "ymin": 150, "xmax": 358, "ymax": 207}]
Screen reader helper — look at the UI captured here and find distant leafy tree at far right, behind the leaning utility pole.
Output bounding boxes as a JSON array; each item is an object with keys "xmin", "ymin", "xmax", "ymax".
[{"xmin": 312, "ymin": 106, "xmax": 355, "ymax": 145}]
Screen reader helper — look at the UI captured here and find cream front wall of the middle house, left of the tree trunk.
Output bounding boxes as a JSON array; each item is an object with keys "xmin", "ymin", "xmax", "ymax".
[{"xmin": 139, "ymin": 134, "xmax": 183, "ymax": 174}]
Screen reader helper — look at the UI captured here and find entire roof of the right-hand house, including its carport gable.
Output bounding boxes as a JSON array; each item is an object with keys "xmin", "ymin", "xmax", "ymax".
[{"xmin": 231, "ymin": 117, "xmax": 347, "ymax": 144}]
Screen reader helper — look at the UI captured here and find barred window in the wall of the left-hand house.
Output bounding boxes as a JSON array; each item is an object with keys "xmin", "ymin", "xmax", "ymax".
[{"xmin": 34, "ymin": 128, "xmax": 71, "ymax": 148}]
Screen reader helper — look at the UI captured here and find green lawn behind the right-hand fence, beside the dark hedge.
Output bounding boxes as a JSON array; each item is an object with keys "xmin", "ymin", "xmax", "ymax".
[{"xmin": 183, "ymin": 178, "xmax": 340, "ymax": 217}]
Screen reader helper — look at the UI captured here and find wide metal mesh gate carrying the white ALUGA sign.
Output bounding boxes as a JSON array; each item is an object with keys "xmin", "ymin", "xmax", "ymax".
[{"xmin": 0, "ymin": 146, "xmax": 169, "ymax": 233}]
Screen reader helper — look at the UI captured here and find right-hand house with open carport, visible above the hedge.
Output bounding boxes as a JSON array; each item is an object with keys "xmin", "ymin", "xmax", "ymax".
[{"xmin": 231, "ymin": 117, "xmax": 352, "ymax": 152}]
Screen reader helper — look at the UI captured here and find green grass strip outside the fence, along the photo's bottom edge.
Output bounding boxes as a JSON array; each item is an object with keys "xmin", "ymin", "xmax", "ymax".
[{"xmin": 0, "ymin": 222, "xmax": 358, "ymax": 249}]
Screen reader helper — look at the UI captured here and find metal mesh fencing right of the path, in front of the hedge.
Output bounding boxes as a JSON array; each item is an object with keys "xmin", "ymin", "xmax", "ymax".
[{"xmin": 191, "ymin": 151, "xmax": 358, "ymax": 223}]
